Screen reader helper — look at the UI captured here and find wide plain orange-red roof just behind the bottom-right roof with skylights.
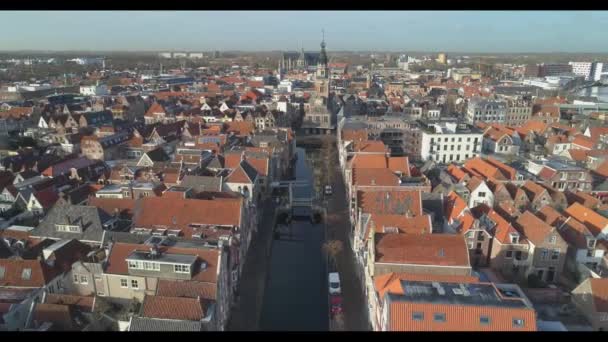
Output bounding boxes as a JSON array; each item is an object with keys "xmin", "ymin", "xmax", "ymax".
[{"xmin": 375, "ymin": 234, "xmax": 470, "ymax": 267}]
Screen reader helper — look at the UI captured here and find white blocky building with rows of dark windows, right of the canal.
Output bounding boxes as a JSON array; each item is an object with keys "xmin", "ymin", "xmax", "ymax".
[{"xmin": 420, "ymin": 122, "xmax": 483, "ymax": 163}]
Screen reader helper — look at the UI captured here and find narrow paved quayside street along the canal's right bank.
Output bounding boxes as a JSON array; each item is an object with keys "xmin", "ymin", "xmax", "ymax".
[{"xmin": 327, "ymin": 148, "xmax": 369, "ymax": 331}]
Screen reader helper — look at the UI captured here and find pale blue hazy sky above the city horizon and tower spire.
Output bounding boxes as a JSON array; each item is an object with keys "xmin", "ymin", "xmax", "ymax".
[{"xmin": 0, "ymin": 11, "xmax": 608, "ymax": 53}]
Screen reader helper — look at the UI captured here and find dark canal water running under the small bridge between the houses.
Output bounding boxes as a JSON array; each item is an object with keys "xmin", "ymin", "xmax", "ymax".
[{"xmin": 260, "ymin": 148, "xmax": 329, "ymax": 331}]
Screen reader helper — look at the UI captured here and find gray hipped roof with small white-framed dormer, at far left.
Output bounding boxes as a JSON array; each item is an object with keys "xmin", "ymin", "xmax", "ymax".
[{"xmin": 32, "ymin": 204, "xmax": 112, "ymax": 243}]
